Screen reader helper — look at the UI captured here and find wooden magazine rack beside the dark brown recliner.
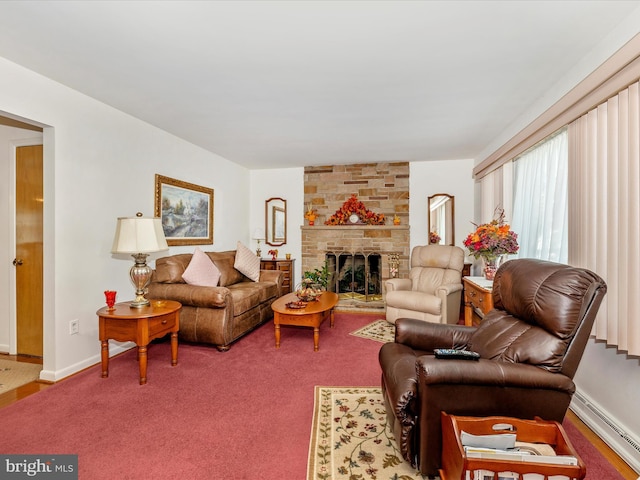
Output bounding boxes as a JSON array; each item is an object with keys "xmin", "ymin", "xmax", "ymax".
[{"xmin": 440, "ymin": 412, "xmax": 587, "ymax": 480}]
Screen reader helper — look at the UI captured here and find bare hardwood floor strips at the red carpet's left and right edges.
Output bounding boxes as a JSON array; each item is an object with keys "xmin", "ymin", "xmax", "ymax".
[{"xmin": 0, "ymin": 355, "xmax": 639, "ymax": 480}]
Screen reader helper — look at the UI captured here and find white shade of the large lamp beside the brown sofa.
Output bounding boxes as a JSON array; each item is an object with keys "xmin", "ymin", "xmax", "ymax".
[{"xmin": 111, "ymin": 216, "xmax": 169, "ymax": 253}]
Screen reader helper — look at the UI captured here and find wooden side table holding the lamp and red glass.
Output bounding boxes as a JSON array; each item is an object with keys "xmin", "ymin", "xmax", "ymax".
[{"xmin": 96, "ymin": 300, "xmax": 182, "ymax": 385}]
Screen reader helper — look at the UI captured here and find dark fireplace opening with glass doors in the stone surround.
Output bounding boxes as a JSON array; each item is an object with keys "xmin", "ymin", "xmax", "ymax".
[{"xmin": 325, "ymin": 253, "xmax": 382, "ymax": 302}]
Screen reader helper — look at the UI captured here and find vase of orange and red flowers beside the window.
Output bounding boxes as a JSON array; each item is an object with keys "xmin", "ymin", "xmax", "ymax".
[{"xmin": 463, "ymin": 210, "xmax": 520, "ymax": 280}]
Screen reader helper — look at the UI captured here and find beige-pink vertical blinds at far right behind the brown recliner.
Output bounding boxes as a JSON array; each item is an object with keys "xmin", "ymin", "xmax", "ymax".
[{"xmin": 569, "ymin": 83, "xmax": 640, "ymax": 355}]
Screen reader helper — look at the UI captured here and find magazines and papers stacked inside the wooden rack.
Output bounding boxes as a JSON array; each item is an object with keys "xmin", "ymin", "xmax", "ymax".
[{"xmin": 460, "ymin": 431, "xmax": 578, "ymax": 480}]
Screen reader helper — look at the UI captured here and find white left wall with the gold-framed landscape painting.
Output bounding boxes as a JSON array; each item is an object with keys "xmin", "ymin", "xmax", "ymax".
[{"xmin": 0, "ymin": 58, "xmax": 250, "ymax": 380}]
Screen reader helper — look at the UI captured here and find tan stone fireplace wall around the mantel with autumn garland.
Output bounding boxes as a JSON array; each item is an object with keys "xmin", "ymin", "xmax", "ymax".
[{"xmin": 301, "ymin": 162, "xmax": 410, "ymax": 288}]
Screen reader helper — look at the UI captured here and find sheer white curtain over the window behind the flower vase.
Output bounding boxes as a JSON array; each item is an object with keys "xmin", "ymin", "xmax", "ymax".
[{"xmin": 511, "ymin": 128, "xmax": 568, "ymax": 263}]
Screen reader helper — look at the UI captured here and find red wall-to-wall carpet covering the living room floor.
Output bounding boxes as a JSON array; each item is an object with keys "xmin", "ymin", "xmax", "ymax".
[{"xmin": 0, "ymin": 313, "xmax": 621, "ymax": 480}]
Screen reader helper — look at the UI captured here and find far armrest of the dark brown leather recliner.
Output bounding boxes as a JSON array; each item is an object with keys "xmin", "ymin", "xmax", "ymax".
[{"xmin": 395, "ymin": 318, "xmax": 476, "ymax": 352}]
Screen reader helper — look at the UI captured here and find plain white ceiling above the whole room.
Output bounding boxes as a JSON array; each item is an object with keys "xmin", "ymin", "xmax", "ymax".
[{"xmin": 0, "ymin": 0, "xmax": 640, "ymax": 168}]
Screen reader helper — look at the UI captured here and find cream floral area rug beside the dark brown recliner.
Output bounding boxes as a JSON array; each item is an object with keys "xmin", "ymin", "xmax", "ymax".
[{"xmin": 307, "ymin": 386, "xmax": 425, "ymax": 480}]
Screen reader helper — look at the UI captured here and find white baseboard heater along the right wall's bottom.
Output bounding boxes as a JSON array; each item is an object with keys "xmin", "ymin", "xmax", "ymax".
[{"xmin": 571, "ymin": 392, "xmax": 640, "ymax": 472}]
